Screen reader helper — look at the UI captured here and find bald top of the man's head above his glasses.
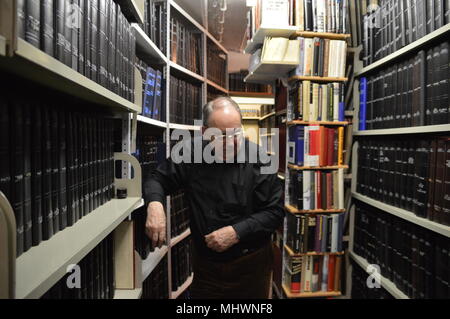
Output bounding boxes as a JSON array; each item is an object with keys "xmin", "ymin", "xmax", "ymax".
[{"xmin": 203, "ymin": 97, "xmax": 242, "ymax": 131}]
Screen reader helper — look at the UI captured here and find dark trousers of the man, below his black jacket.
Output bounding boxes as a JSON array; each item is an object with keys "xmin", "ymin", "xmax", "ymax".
[{"xmin": 190, "ymin": 243, "xmax": 273, "ymax": 299}]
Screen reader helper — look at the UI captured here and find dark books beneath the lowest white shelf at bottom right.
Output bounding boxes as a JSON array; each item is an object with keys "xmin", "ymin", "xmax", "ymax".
[{"xmin": 351, "ymin": 262, "xmax": 394, "ymax": 299}]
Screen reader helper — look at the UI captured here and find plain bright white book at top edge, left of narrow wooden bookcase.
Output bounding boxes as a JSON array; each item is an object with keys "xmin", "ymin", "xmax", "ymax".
[{"xmin": 261, "ymin": 0, "xmax": 289, "ymax": 27}]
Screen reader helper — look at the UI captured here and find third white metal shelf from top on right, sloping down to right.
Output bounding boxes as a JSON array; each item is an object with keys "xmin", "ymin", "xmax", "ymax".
[{"xmin": 352, "ymin": 192, "xmax": 450, "ymax": 237}]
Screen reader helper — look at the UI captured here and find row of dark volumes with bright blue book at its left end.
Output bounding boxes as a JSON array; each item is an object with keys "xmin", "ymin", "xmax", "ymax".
[{"xmin": 359, "ymin": 41, "xmax": 450, "ymax": 130}]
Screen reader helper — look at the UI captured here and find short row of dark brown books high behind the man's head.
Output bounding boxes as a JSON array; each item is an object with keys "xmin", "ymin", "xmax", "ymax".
[{"xmin": 206, "ymin": 39, "xmax": 227, "ymax": 88}]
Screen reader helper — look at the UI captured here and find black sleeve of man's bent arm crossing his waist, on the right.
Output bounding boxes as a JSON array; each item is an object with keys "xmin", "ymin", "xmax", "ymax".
[{"xmin": 233, "ymin": 170, "xmax": 284, "ymax": 240}]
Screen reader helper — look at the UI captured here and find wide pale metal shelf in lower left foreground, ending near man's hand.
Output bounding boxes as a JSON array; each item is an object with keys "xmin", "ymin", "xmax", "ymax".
[{"xmin": 16, "ymin": 197, "xmax": 143, "ymax": 299}]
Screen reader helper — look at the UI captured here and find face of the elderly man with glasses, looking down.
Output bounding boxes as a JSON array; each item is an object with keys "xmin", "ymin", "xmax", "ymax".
[{"xmin": 209, "ymin": 106, "xmax": 243, "ymax": 160}]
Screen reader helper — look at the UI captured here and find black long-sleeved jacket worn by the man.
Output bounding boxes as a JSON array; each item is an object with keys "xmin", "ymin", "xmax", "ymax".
[{"xmin": 144, "ymin": 140, "xmax": 284, "ymax": 261}]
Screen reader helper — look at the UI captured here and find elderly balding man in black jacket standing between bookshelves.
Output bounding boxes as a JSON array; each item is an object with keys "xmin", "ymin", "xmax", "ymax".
[{"xmin": 144, "ymin": 97, "xmax": 284, "ymax": 298}]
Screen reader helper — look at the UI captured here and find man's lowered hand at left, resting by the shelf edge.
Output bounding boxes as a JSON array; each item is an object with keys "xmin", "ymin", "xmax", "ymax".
[{"xmin": 145, "ymin": 202, "xmax": 166, "ymax": 248}]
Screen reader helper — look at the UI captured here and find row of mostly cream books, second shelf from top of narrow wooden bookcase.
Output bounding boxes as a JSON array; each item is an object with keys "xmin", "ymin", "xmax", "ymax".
[{"xmin": 289, "ymin": 37, "xmax": 347, "ymax": 78}]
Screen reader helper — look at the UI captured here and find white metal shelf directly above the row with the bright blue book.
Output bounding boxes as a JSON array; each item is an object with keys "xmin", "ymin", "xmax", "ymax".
[{"xmin": 355, "ymin": 23, "xmax": 450, "ymax": 77}]
